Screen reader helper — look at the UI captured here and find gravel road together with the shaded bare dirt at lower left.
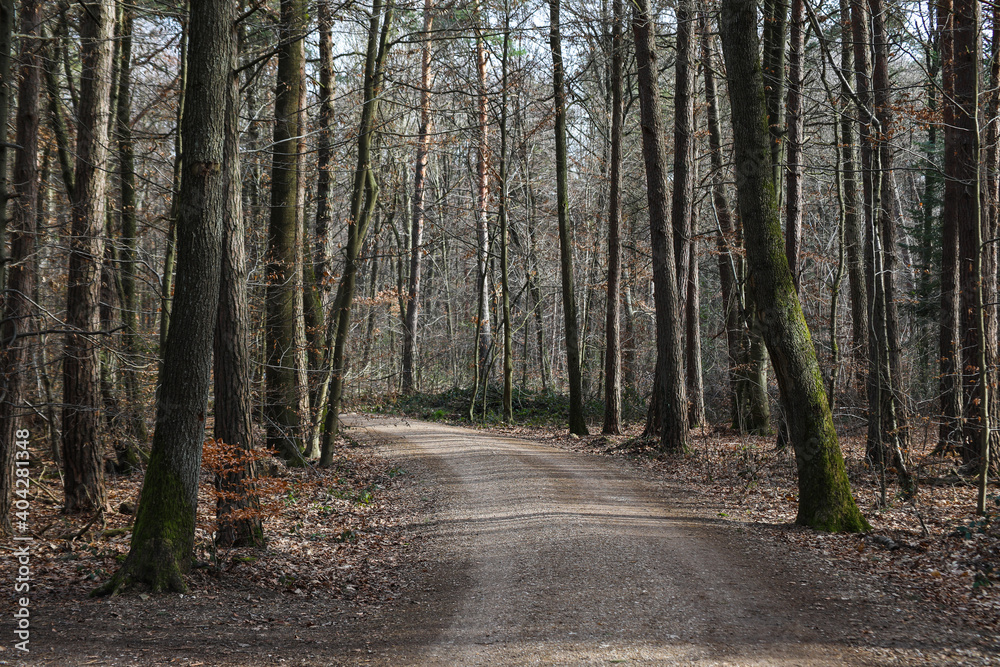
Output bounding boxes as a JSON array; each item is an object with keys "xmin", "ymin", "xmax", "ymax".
[{"xmin": 17, "ymin": 416, "xmax": 1000, "ymax": 667}]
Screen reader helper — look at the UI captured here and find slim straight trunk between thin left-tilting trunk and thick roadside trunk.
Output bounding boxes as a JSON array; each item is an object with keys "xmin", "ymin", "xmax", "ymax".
[{"xmin": 602, "ymin": 0, "xmax": 625, "ymax": 435}]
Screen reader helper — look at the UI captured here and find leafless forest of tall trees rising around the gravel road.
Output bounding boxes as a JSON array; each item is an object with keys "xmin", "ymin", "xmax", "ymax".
[{"xmin": 0, "ymin": 0, "xmax": 1000, "ymax": 594}]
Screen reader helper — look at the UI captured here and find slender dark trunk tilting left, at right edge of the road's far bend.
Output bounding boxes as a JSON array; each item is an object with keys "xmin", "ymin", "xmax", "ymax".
[{"xmin": 549, "ymin": 0, "xmax": 587, "ymax": 435}]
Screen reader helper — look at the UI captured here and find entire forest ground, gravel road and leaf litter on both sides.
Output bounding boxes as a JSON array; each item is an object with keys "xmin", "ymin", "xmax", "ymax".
[{"xmin": 0, "ymin": 417, "xmax": 1000, "ymax": 665}]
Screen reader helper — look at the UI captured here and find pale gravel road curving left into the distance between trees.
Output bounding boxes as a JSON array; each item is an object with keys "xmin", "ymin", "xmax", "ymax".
[{"xmin": 350, "ymin": 417, "xmax": 988, "ymax": 665}]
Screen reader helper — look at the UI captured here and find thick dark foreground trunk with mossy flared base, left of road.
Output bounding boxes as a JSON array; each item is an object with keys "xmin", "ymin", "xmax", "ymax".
[{"xmin": 96, "ymin": 0, "xmax": 236, "ymax": 594}]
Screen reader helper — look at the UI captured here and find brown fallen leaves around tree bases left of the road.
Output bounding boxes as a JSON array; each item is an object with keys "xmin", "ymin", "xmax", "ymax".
[{"xmin": 0, "ymin": 441, "xmax": 414, "ymax": 604}]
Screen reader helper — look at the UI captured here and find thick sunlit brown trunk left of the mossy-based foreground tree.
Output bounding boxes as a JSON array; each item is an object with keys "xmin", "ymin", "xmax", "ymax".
[{"xmin": 62, "ymin": 0, "xmax": 115, "ymax": 512}]
